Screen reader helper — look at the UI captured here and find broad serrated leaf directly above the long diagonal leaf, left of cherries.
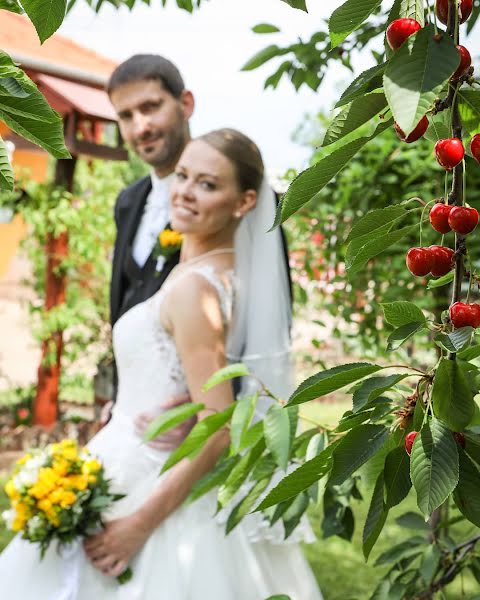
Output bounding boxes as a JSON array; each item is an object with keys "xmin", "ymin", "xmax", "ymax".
[{"xmin": 322, "ymin": 92, "xmax": 387, "ymax": 146}]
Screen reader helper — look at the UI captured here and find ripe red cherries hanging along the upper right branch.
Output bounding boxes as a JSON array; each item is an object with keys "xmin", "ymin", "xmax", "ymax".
[{"xmin": 386, "ymin": 0, "xmax": 480, "ymax": 327}]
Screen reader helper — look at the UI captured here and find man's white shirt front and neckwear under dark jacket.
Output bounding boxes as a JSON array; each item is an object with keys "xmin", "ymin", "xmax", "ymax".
[{"xmin": 132, "ymin": 173, "xmax": 173, "ymax": 267}]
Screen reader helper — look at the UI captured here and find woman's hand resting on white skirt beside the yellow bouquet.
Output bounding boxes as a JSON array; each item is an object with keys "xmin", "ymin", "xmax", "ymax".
[{"xmin": 83, "ymin": 514, "xmax": 149, "ymax": 577}]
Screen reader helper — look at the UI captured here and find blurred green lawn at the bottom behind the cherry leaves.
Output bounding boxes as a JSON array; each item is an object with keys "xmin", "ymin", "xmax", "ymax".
[{"xmin": 0, "ymin": 402, "xmax": 479, "ymax": 600}]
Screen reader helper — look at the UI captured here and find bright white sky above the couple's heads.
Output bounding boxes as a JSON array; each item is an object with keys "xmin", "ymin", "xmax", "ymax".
[{"xmin": 59, "ymin": 0, "xmax": 480, "ymax": 172}]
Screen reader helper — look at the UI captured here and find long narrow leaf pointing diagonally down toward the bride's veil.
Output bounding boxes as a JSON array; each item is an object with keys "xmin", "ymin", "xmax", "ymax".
[{"xmin": 273, "ymin": 119, "xmax": 392, "ymax": 227}]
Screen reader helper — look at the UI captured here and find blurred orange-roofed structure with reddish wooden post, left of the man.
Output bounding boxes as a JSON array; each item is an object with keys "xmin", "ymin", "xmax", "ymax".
[{"xmin": 0, "ymin": 10, "xmax": 127, "ymax": 427}]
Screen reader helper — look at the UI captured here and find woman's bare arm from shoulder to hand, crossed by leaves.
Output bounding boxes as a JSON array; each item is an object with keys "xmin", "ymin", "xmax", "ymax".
[{"xmin": 85, "ymin": 277, "xmax": 233, "ymax": 576}]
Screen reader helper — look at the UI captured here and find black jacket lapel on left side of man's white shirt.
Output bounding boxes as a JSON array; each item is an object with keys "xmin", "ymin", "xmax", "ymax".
[{"xmin": 110, "ymin": 175, "xmax": 152, "ymax": 325}]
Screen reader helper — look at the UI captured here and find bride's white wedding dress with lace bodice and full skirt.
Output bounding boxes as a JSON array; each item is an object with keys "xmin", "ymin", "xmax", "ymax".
[{"xmin": 0, "ymin": 263, "xmax": 322, "ymax": 600}]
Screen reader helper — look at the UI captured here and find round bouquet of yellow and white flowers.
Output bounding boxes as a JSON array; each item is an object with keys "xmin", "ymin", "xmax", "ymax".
[{"xmin": 2, "ymin": 439, "xmax": 132, "ymax": 583}]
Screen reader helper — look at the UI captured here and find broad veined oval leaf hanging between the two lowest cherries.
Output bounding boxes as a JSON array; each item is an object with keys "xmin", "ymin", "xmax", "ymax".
[{"xmin": 410, "ymin": 418, "xmax": 458, "ymax": 517}]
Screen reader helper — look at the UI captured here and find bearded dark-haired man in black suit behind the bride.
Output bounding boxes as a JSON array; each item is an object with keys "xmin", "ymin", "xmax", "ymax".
[{"xmin": 107, "ymin": 54, "xmax": 291, "ymax": 442}]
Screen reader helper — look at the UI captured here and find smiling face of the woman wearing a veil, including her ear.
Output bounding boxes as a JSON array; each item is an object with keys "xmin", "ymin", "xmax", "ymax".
[{"xmin": 171, "ymin": 140, "xmax": 256, "ymax": 235}]
